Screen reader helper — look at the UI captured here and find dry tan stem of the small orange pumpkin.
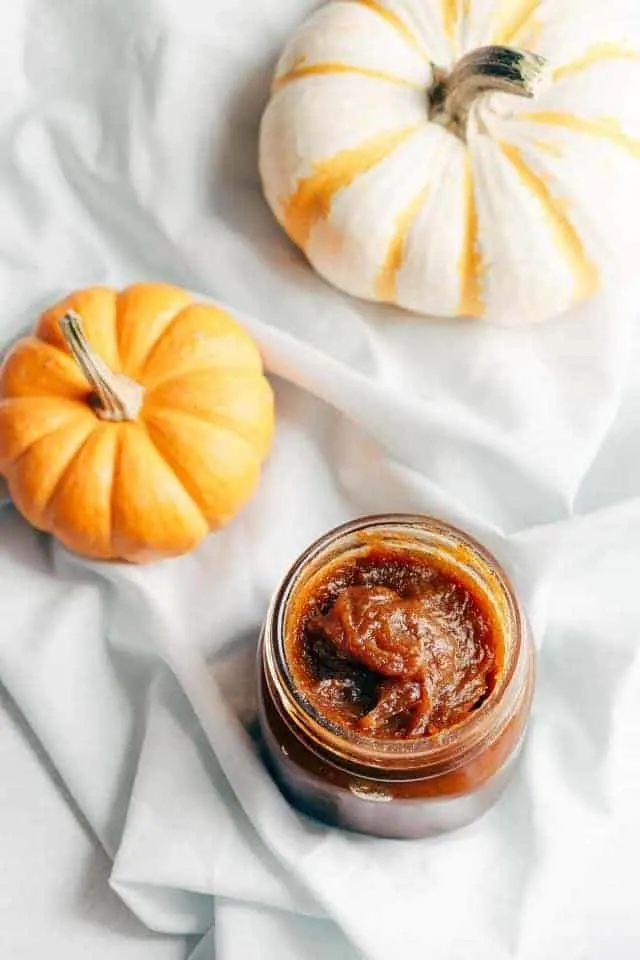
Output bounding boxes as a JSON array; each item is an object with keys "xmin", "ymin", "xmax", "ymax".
[{"xmin": 60, "ymin": 310, "xmax": 144, "ymax": 423}]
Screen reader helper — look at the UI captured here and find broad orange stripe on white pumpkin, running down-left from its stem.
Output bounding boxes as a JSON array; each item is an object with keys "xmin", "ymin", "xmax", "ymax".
[{"xmin": 282, "ymin": 120, "xmax": 427, "ymax": 249}]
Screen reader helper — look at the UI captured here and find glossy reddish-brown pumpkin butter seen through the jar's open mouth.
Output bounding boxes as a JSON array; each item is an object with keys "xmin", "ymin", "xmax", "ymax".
[{"xmin": 286, "ymin": 545, "xmax": 501, "ymax": 738}]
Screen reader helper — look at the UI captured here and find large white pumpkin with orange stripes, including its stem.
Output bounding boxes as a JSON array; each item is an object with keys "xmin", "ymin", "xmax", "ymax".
[{"xmin": 260, "ymin": 0, "xmax": 640, "ymax": 324}]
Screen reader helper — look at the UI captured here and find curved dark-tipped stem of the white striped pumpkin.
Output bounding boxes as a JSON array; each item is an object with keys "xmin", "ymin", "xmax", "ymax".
[{"xmin": 429, "ymin": 46, "xmax": 547, "ymax": 140}]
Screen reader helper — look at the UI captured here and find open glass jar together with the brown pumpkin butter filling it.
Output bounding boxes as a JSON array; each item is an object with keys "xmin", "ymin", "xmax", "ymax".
[{"xmin": 259, "ymin": 514, "xmax": 534, "ymax": 838}]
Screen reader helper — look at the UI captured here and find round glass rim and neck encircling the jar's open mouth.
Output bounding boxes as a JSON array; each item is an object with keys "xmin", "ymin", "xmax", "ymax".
[{"xmin": 263, "ymin": 513, "xmax": 524, "ymax": 777}]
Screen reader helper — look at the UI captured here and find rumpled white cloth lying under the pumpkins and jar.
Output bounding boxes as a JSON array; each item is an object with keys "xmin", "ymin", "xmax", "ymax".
[{"xmin": 0, "ymin": 0, "xmax": 640, "ymax": 960}]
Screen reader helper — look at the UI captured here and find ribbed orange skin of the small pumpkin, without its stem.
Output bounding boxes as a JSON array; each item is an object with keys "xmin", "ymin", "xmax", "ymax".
[{"xmin": 0, "ymin": 284, "xmax": 274, "ymax": 563}]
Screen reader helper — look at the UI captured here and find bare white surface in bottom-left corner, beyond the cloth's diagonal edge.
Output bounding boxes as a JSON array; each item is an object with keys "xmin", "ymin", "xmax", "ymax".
[{"xmin": 0, "ymin": 689, "xmax": 189, "ymax": 960}]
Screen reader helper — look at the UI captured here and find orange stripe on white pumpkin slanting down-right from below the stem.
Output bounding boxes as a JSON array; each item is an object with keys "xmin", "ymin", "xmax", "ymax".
[{"xmin": 498, "ymin": 141, "xmax": 599, "ymax": 301}]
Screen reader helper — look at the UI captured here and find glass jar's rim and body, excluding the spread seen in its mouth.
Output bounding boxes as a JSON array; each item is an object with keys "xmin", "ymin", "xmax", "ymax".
[{"xmin": 258, "ymin": 514, "xmax": 534, "ymax": 838}]
